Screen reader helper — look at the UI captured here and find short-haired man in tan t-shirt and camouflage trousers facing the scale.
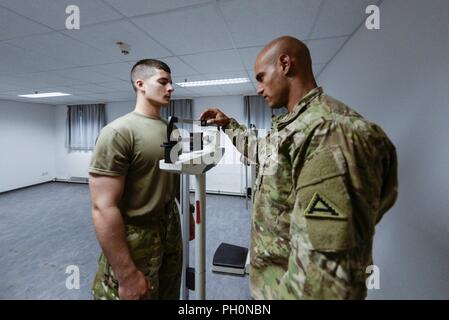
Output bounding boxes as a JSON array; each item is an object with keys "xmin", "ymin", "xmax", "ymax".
[{"xmin": 89, "ymin": 59, "xmax": 188, "ymax": 299}]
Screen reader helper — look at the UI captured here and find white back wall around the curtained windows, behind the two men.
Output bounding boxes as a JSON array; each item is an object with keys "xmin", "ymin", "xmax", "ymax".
[{"xmin": 56, "ymin": 96, "xmax": 245, "ymax": 194}]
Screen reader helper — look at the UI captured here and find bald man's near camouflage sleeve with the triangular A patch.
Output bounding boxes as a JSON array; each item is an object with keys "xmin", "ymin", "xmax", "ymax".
[{"xmin": 279, "ymin": 122, "xmax": 397, "ymax": 299}]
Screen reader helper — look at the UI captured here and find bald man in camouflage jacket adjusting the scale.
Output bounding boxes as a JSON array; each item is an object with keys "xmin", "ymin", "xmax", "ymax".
[{"xmin": 201, "ymin": 36, "xmax": 397, "ymax": 299}]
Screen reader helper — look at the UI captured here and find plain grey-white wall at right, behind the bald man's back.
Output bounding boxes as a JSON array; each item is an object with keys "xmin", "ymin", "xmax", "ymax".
[{"xmin": 318, "ymin": 0, "xmax": 449, "ymax": 299}]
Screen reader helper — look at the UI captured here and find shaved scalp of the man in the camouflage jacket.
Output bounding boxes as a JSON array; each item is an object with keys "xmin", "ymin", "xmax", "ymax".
[{"xmin": 256, "ymin": 36, "xmax": 313, "ymax": 77}]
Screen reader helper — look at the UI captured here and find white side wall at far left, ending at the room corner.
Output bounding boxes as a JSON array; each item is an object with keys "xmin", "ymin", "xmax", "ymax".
[{"xmin": 0, "ymin": 100, "xmax": 55, "ymax": 192}]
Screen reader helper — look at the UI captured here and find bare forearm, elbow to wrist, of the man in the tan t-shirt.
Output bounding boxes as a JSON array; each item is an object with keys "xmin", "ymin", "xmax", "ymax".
[{"xmin": 92, "ymin": 207, "xmax": 137, "ymax": 282}]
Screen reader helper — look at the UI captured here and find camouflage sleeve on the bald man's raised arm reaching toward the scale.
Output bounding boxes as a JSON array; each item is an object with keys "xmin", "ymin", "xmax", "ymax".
[{"xmin": 224, "ymin": 118, "xmax": 258, "ymax": 164}]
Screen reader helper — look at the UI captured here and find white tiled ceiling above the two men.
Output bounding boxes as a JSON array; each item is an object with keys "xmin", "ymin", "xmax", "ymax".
[{"xmin": 0, "ymin": 0, "xmax": 378, "ymax": 104}]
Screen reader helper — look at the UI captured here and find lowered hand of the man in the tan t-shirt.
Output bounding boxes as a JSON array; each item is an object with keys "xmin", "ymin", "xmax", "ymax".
[{"xmin": 118, "ymin": 269, "xmax": 153, "ymax": 300}]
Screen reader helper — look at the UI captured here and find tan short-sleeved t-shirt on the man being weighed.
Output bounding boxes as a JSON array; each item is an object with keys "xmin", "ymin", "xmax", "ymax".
[{"xmin": 89, "ymin": 112, "xmax": 179, "ymax": 217}]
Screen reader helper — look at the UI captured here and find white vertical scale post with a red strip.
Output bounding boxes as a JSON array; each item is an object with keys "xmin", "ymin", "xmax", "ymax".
[{"xmin": 195, "ymin": 173, "xmax": 206, "ymax": 300}]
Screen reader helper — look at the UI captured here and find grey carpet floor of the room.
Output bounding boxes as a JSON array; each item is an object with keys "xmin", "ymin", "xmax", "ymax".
[{"xmin": 0, "ymin": 182, "xmax": 250, "ymax": 300}]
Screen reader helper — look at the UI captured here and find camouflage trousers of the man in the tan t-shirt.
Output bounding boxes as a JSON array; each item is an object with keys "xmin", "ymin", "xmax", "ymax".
[{"xmin": 92, "ymin": 201, "xmax": 182, "ymax": 300}]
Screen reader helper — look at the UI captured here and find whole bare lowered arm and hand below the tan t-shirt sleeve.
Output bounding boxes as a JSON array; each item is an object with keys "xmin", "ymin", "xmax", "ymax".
[{"xmin": 89, "ymin": 173, "xmax": 149, "ymax": 299}]
